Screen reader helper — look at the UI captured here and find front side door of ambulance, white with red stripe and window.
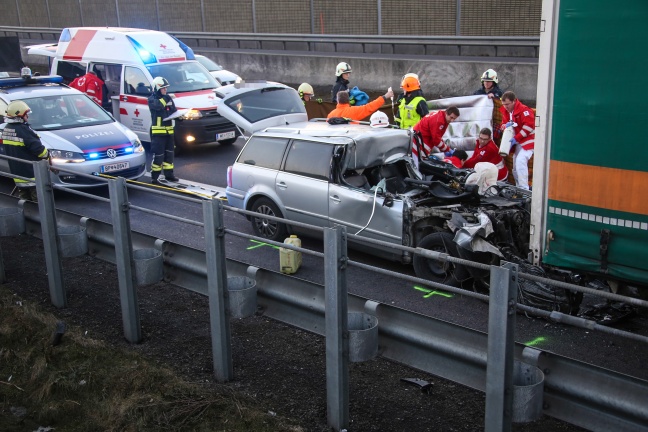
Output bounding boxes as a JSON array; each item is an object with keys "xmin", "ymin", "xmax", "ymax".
[{"xmin": 119, "ymin": 66, "xmax": 152, "ymax": 142}]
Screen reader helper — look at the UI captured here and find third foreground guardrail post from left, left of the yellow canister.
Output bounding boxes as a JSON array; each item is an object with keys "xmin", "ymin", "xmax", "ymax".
[{"xmin": 203, "ymin": 199, "xmax": 234, "ymax": 382}]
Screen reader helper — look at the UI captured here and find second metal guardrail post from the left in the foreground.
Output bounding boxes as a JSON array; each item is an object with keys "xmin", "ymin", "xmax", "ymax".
[{"xmin": 108, "ymin": 177, "xmax": 142, "ymax": 343}]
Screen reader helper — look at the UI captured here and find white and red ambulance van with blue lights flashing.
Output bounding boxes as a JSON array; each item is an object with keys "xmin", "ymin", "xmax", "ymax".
[{"xmin": 28, "ymin": 27, "xmax": 240, "ymax": 149}]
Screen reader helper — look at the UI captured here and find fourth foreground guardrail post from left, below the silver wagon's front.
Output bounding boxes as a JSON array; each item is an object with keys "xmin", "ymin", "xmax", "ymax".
[{"xmin": 324, "ymin": 226, "xmax": 349, "ymax": 431}]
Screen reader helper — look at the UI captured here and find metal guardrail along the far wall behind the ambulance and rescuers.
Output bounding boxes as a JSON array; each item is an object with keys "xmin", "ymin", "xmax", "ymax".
[{"xmin": 0, "ymin": 26, "xmax": 540, "ymax": 58}]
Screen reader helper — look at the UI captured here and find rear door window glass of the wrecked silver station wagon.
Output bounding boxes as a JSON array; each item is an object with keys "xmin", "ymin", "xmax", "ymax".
[{"xmin": 284, "ymin": 140, "xmax": 333, "ymax": 180}]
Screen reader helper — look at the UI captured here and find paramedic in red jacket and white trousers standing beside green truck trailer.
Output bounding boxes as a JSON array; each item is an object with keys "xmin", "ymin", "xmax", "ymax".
[{"xmin": 500, "ymin": 91, "xmax": 535, "ymax": 190}]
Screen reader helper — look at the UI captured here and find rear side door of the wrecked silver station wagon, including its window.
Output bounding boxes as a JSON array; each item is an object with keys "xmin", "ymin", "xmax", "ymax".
[{"xmin": 275, "ymin": 140, "xmax": 334, "ymax": 227}]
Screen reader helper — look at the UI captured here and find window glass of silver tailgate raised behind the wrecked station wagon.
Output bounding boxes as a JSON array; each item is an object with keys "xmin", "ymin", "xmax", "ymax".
[{"xmin": 225, "ymin": 87, "xmax": 306, "ymax": 123}]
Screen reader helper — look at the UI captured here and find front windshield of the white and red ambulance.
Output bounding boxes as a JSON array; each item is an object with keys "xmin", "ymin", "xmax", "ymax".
[{"xmin": 148, "ymin": 61, "xmax": 220, "ymax": 93}]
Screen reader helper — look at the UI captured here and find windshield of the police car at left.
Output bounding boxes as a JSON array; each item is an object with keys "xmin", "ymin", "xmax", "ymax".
[{"xmin": 23, "ymin": 94, "xmax": 114, "ymax": 131}]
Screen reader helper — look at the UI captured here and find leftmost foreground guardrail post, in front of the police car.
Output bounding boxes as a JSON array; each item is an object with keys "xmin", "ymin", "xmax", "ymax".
[{"xmin": 34, "ymin": 160, "xmax": 67, "ymax": 308}]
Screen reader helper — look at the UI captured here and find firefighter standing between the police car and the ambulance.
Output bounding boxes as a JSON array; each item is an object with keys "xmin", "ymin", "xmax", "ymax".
[{"xmin": 148, "ymin": 77, "xmax": 178, "ymax": 185}]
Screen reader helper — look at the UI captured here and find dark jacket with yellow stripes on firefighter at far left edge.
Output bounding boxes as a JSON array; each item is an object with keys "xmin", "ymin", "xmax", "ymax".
[{"xmin": 0, "ymin": 118, "xmax": 48, "ymax": 183}]
